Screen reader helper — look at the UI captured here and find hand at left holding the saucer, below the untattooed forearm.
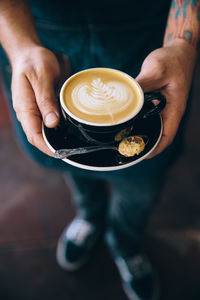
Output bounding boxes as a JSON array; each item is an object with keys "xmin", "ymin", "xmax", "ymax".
[{"xmin": 12, "ymin": 46, "xmax": 60, "ymax": 156}]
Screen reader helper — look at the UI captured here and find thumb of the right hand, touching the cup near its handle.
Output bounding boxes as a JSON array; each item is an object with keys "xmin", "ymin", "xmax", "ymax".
[{"xmin": 136, "ymin": 60, "xmax": 167, "ymax": 93}]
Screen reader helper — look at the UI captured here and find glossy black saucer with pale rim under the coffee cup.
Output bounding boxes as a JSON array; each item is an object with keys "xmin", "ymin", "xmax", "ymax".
[{"xmin": 42, "ymin": 109, "xmax": 163, "ymax": 171}]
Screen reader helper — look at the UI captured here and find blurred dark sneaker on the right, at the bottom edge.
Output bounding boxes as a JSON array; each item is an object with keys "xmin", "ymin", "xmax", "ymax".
[{"xmin": 115, "ymin": 255, "xmax": 159, "ymax": 300}]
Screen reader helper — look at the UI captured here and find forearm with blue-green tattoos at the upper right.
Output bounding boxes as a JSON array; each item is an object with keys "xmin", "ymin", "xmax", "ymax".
[{"xmin": 164, "ymin": 0, "xmax": 200, "ymax": 46}]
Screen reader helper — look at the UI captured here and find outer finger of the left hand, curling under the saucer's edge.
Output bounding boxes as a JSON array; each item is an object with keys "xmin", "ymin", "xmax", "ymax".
[{"xmin": 12, "ymin": 76, "xmax": 52, "ymax": 156}]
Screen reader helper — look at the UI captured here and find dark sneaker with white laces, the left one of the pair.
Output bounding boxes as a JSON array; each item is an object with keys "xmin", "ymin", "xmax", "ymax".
[{"xmin": 56, "ymin": 217, "xmax": 102, "ymax": 271}]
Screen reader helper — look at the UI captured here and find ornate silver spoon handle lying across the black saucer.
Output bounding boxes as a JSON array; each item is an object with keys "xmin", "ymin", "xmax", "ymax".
[{"xmin": 54, "ymin": 145, "xmax": 116, "ymax": 159}]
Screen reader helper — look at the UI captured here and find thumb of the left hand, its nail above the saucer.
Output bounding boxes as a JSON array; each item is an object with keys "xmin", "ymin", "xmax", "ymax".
[{"xmin": 31, "ymin": 76, "xmax": 59, "ymax": 128}]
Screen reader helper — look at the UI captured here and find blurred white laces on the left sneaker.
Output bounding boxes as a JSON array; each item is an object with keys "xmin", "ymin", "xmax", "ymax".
[{"xmin": 66, "ymin": 219, "xmax": 95, "ymax": 245}]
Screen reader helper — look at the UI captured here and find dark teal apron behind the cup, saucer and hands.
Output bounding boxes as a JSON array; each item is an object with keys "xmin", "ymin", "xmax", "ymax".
[{"xmin": 0, "ymin": 0, "xmax": 184, "ymax": 180}]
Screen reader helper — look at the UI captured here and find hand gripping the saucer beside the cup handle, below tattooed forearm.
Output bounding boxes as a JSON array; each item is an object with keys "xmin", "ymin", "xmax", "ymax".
[{"xmin": 136, "ymin": 39, "xmax": 196, "ymax": 158}]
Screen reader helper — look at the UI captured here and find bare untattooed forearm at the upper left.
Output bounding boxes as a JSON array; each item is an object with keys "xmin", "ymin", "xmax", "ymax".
[{"xmin": 0, "ymin": 0, "xmax": 40, "ymax": 62}]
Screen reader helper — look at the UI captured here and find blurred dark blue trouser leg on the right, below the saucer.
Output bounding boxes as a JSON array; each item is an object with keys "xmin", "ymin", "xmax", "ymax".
[{"xmin": 107, "ymin": 180, "xmax": 161, "ymax": 257}]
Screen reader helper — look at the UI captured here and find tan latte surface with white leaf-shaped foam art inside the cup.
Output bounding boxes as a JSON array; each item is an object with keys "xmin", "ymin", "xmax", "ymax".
[{"xmin": 64, "ymin": 69, "xmax": 140, "ymax": 125}]
